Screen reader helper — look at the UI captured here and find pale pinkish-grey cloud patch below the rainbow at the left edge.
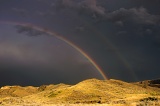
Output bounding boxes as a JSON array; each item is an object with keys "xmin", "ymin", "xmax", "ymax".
[{"xmin": 0, "ymin": 41, "xmax": 49, "ymax": 64}]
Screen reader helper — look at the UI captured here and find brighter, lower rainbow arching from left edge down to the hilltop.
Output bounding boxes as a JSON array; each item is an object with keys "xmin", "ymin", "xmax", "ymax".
[{"xmin": 0, "ymin": 21, "xmax": 108, "ymax": 80}]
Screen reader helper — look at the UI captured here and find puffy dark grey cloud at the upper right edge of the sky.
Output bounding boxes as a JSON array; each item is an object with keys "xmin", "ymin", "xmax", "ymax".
[{"xmin": 106, "ymin": 7, "xmax": 160, "ymax": 25}]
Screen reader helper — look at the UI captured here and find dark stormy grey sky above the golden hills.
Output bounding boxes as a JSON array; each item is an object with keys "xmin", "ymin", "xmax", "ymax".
[{"xmin": 0, "ymin": 0, "xmax": 160, "ymax": 86}]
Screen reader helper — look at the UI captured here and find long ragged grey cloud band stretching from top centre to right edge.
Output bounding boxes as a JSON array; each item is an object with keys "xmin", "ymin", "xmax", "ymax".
[{"xmin": 53, "ymin": 0, "xmax": 160, "ymax": 25}]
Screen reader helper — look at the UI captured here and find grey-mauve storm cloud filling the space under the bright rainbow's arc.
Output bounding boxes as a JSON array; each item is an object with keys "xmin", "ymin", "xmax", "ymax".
[{"xmin": 0, "ymin": 34, "xmax": 101, "ymax": 86}]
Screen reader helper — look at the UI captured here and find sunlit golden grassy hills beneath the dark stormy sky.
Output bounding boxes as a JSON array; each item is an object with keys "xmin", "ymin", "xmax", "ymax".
[{"xmin": 0, "ymin": 79, "xmax": 160, "ymax": 106}]
